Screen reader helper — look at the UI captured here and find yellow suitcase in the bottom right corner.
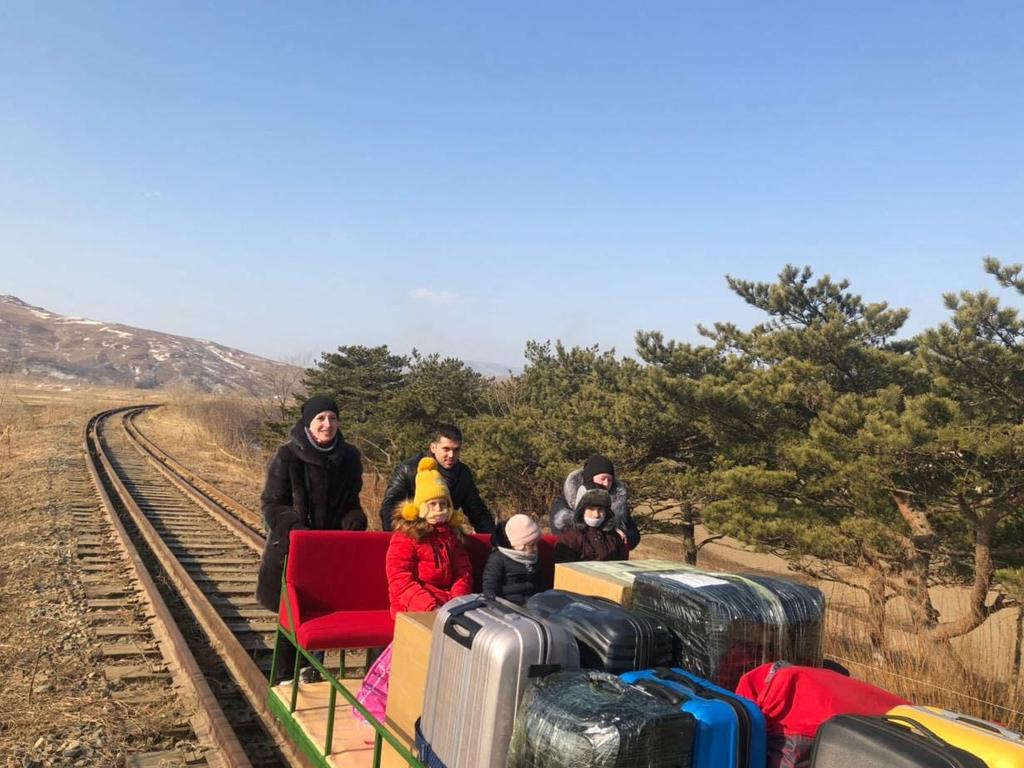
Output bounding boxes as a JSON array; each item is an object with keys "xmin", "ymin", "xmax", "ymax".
[{"xmin": 888, "ymin": 706, "xmax": 1024, "ymax": 768}]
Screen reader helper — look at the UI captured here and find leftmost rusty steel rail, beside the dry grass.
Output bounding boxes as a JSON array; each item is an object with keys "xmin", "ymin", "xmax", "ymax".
[{"xmin": 82, "ymin": 409, "xmax": 252, "ymax": 768}]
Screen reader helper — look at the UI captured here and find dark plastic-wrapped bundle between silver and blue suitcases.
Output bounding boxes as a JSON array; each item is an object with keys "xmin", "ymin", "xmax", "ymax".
[{"xmin": 508, "ymin": 671, "xmax": 694, "ymax": 768}]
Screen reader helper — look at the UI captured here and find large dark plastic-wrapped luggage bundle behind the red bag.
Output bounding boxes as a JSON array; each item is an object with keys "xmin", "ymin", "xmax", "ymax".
[{"xmin": 633, "ymin": 570, "xmax": 825, "ymax": 690}]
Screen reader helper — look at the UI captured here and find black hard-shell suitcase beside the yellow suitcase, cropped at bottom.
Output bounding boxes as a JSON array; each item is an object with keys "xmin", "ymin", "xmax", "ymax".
[{"xmin": 810, "ymin": 715, "xmax": 986, "ymax": 768}]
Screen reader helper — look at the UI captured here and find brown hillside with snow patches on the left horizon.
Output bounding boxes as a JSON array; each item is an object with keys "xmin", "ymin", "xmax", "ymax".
[{"xmin": 0, "ymin": 296, "xmax": 298, "ymax": 394}]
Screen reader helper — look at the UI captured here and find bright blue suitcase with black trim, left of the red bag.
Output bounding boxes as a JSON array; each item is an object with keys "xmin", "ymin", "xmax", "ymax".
[{"xmin": 620, "ymin": 667, "xmax": 768, "ymax": 768}]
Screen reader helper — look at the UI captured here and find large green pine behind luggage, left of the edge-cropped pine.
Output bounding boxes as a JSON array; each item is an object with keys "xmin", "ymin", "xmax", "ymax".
[{"xmin": 639, "ymin": 266, "xmax": 927, "ymax": 644}]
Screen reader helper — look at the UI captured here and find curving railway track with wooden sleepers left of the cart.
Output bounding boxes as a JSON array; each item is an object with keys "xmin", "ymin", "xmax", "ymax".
[{"xmin": 83, "ymin": 407, "xmax": 306, "ymax": 768}]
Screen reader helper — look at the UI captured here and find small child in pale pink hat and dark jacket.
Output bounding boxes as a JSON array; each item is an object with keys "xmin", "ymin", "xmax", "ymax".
[{"xmin": 483, "ymin": 514, "xmax": 541, "ymax": 605}]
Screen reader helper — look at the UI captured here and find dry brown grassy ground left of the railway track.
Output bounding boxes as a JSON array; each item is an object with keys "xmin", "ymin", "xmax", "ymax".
[{"xmin": 0, "ymin": 378, "xmax": 188, "ymax": 765}]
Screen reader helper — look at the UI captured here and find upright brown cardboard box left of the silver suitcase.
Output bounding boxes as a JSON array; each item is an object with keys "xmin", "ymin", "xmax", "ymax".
[{"xmin": 385, "ymin": 612, "xmax": 437, "ymax": 741}]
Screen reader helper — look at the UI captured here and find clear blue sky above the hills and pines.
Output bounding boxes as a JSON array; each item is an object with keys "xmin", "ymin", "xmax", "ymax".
[{"xmin": 0, "ymin": 2, "xmax": 1024, "ymax": 365}]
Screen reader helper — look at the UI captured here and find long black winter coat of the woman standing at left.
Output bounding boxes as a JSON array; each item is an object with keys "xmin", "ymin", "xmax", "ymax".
[{"xmin": 256, "ymin": 421, "xmax": 367, "ymax": 613}]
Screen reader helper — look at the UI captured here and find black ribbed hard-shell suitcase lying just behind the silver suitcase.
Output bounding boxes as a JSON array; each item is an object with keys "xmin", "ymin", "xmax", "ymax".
[{"xmin": 526, "ymin": 590, "xmax": 672, "ymax": 674}]
